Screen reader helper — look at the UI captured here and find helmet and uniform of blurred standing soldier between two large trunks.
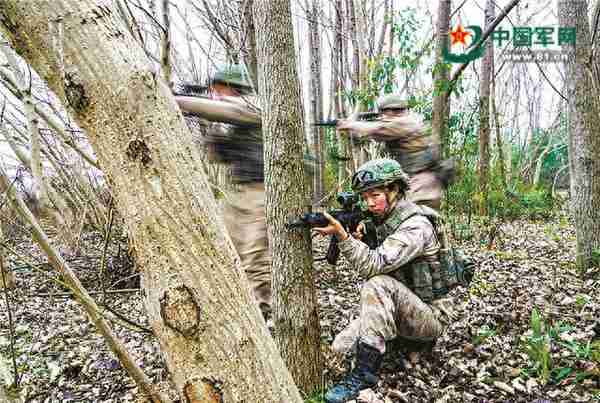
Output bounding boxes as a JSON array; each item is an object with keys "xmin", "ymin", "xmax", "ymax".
[{"xmin": 176, "ymin": 66, "xmax": 271, "ymax": 319}]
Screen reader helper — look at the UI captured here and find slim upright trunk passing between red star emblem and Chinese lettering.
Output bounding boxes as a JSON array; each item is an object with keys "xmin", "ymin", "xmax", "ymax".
[{"xmin": 478, "ymin": 0, "xmax": 494, "ymax": 215}]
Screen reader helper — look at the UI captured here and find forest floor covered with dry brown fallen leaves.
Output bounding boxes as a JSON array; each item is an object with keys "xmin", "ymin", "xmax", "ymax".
[{"xmin": 0, "ymin": 210, "xmax": 600, "ymax": 403}]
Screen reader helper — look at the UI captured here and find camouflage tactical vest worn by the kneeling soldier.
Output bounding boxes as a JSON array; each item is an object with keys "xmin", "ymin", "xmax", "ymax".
[{"xmin": 376, "ymin": 203, "xmax": 452, "ymax": 302}]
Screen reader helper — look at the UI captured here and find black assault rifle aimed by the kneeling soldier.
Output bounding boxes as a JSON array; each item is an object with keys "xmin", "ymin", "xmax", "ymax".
[{"xmin": 287, "ymin": 192, "xmax": 377, "ymax": 266}]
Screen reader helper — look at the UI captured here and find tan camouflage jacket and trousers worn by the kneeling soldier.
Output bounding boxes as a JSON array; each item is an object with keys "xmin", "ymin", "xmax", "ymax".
[{"xmin": 334, "ymin": 200, "xmax": 447, "ymax": 353}]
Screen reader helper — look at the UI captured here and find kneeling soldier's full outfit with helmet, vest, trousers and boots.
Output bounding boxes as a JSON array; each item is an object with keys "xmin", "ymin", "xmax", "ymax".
[{"xmin": 325, "ymin": 158, "xmax": 451, "ymax": 403}]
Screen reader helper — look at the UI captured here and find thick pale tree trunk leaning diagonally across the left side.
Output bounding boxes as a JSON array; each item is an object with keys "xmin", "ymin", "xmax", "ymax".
[{"xmin": 0, "ymin": 0, "xmax": 301, "ymax": 403}]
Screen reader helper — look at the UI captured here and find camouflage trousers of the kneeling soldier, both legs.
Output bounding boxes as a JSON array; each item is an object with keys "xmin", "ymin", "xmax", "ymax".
[{"xmin": 332, "ymin": 275, "xmax": 453, "ymax": 353}]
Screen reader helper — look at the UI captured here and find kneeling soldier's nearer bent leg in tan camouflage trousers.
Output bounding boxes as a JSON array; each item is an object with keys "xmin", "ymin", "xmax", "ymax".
[{"xmin": 360, "ymin": 275, "xmax": 443, "ymax": 353}]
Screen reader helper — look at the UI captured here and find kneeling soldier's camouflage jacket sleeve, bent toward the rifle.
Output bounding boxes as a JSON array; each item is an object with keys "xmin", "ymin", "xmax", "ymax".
[{"xmin": 338, "ymin": 216, "xmax": 439, "ymax": 278}]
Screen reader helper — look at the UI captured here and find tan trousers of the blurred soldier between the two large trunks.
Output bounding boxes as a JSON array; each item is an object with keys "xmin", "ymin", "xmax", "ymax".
[{"xmin": 224, "ymin": 182, "xmax": 271, "ymax": 319}]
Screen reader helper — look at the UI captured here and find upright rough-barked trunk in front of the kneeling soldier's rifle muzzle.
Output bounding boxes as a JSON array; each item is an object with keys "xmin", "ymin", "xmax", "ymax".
[{"xmin": 254, "ymin": 0, "xmax": 323, "ymax": 393}]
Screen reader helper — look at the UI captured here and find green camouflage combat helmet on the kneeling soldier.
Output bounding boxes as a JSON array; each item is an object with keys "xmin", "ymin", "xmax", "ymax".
[{"xmin": 352, "ymin": 158, "xmax": 408, "ymax": 193}]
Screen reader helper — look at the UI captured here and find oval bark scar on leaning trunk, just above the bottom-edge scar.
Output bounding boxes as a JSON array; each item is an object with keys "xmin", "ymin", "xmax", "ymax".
[{"xmin": 160, "ymin": 284, "xmax": 200, "ymax": 337}]
